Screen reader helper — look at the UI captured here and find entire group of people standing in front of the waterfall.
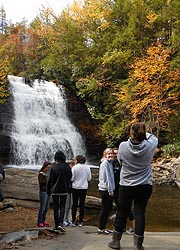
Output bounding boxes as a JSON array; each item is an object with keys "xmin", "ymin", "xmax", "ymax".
[{"xmin": 35, "ymin": 122, "xmax": 158, "ymax": 250}]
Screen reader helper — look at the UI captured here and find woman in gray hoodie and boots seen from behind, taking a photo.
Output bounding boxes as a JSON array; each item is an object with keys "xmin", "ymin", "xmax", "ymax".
[{"xmin": 108, "ymin": 122, "xmax": 158, "ymax": 250}]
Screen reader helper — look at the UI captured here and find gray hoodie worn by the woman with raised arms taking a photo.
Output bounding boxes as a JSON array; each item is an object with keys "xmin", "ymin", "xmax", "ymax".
[{"xmin": 118, "ymin": 133, "xmax": 158, "ymax": 186}]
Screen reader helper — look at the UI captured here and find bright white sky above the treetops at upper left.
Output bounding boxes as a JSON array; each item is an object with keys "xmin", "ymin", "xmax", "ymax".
[{"xmin": 0, "ymin": 0, "xmax": 74, "ymax": 23}]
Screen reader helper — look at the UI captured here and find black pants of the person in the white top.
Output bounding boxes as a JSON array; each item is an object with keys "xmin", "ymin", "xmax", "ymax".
[{"xmin": 72, "ymin": 188, "xmax": 87, "ymax": 223}]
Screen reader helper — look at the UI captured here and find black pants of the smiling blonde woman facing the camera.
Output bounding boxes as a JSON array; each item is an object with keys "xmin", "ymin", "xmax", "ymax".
[{"xmin": 99, "ymin": 190, "xmax": 113, "ymax": 230}]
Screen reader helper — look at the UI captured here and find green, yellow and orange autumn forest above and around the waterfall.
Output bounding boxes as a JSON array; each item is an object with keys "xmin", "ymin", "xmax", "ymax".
[{"xmin": 0, "ymin": 0, "xmax": 180, "ymax": 146}]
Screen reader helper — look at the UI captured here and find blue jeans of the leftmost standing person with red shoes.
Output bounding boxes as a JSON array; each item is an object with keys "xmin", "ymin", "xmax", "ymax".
[{"xmin": 37, "ymin": 191, "xmax": 50, "ymax": 225}]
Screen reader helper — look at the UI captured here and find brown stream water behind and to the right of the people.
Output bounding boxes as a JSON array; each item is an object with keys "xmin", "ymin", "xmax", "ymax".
[{"xmin": 85, "ymin": 169, "xmax": 180, "ymax": 232}]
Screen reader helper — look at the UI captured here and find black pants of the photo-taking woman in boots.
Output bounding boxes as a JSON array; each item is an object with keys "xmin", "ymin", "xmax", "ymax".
[{"xmin": 115, "ymin": 185, "xmax": 152, "ymax": 236}]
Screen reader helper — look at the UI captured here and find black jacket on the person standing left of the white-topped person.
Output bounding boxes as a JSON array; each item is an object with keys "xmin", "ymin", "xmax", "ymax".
[{"xmin": 47, "ymin": 161, "xmax": 72, "ymax": 195}]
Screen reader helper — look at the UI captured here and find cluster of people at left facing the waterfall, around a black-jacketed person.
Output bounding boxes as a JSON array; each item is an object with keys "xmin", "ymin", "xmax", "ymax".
[{"xmin": 37, "ymin": 151, "xmax": 91, "ymax": 232}]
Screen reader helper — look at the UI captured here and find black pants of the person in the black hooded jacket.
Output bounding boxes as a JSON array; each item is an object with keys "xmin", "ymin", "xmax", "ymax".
[{"xmin": 52, "ymin": 195, "xmax": 67, "ymax": 228}]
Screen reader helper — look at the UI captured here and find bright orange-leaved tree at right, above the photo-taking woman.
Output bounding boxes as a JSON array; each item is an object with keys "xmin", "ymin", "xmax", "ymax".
[{"xmin": 119, "ymin": 43, "xmax": 180, "ymax": 141}]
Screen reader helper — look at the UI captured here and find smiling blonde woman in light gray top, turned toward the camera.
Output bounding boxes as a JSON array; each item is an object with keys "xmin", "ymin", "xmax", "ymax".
[{"xmin": 98, "ymin": 148, "xmax": 115, "ymax": 234}]
